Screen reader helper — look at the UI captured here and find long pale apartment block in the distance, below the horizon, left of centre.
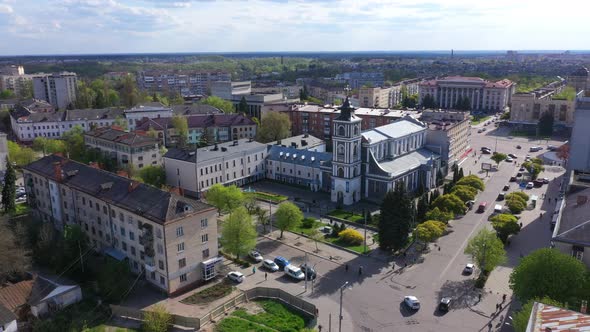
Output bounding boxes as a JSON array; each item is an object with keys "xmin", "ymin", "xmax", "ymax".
[{"xmin": 137, "ymin": 70, "xmax": 231, "ymax": 96}]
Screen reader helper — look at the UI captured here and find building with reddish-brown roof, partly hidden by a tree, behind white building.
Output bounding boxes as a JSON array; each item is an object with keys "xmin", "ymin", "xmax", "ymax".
[{"xmin": 135, "ymin": 113, "xmax": 258, "ymax": 146}]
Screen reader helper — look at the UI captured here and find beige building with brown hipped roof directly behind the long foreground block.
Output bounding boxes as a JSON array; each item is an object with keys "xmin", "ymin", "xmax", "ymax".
[{"xmin": 84, "ymin": 127, "xmax": 162, "ymax": 169}]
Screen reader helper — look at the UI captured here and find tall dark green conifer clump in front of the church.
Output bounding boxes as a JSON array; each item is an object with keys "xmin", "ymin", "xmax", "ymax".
[{"xmin": 379, "ymin": 181, "xmax": 414, "ymax": 250}]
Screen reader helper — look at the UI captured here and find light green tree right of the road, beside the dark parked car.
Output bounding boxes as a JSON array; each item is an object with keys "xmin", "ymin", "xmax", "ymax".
[{"xmin": 464, "ymin": 229, "xmax": 506, "ymax": 274}]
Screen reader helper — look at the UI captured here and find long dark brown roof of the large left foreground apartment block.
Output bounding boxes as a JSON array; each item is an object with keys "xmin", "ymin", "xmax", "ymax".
[{"xmin": 24, "ymin": 155, "xmax": 212, "ymax": 224}]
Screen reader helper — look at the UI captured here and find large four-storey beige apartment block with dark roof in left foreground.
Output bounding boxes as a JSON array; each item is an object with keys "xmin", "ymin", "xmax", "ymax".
[{"xmin": 23, "ymin": 155, "xmax": 220, "ymax": 294}]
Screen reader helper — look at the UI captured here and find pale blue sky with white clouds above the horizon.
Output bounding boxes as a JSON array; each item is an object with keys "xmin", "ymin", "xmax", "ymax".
[{"xmin": 0, "ymin": 0, "xmax": 590, "ymax": 55}]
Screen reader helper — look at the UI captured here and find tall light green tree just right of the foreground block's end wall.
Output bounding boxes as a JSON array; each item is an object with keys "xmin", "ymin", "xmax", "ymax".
[{"xmin": 220, "ymin": 206, "xmax": 258, "ymax": 258}]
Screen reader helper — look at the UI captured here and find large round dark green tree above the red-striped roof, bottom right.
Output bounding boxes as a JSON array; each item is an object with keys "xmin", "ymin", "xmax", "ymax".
[{"xmin": 510, "ymin": 248, "xmax": 588, "ymax": 303}]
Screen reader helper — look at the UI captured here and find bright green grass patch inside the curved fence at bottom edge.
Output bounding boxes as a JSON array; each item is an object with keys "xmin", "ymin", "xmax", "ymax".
[{"xmin": 232, "ymin": 300, "xmax": 307, "ymax": 332}]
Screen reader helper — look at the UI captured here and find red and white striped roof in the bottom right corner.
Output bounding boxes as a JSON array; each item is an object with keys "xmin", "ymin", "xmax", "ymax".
[{"xmin": 526, "ymin": 302, "xmax": 590, "ymax": 332}]
